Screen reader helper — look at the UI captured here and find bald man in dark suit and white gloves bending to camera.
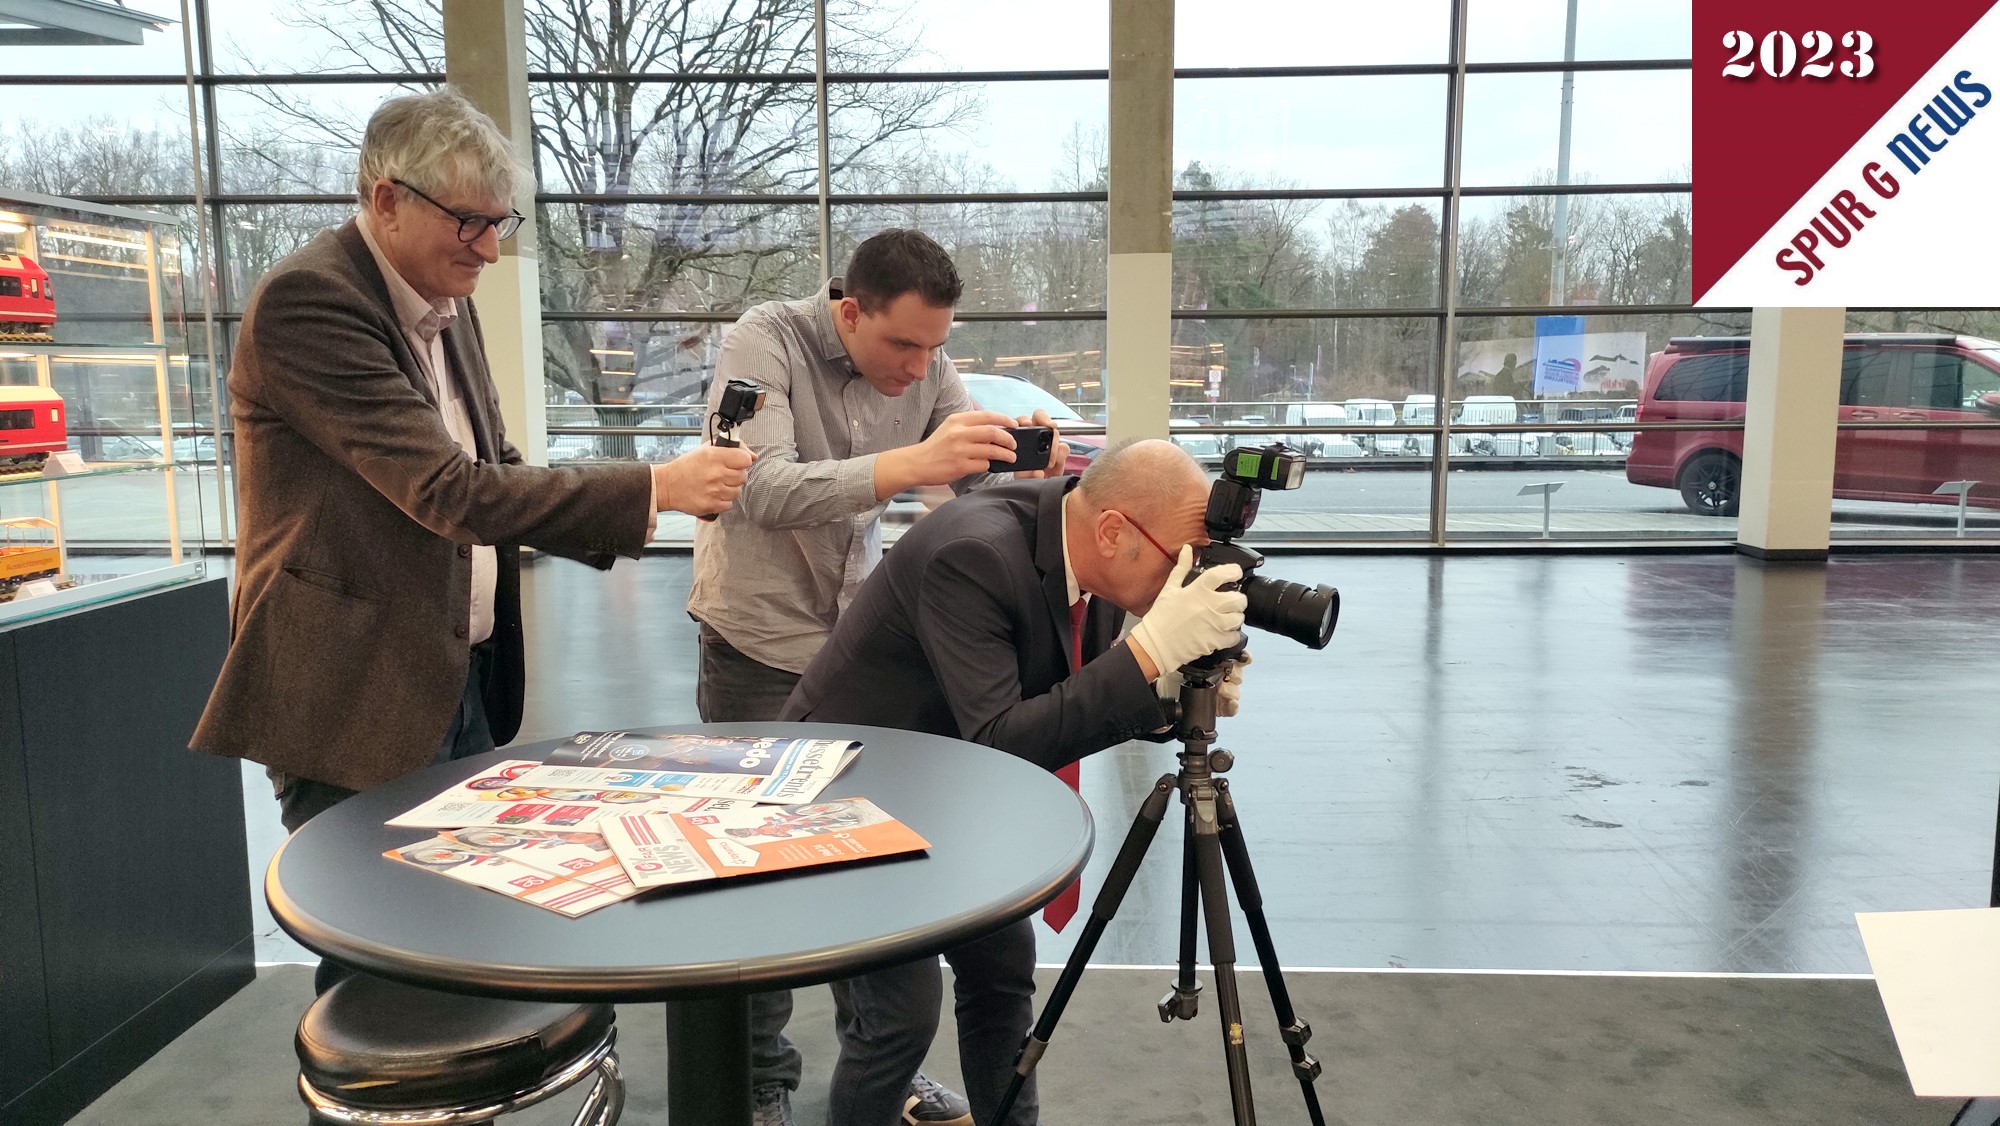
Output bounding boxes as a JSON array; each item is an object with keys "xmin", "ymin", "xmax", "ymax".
[{"xmin": 784, "ymin": 442, "xmax": 1244, "ymax": 1126}]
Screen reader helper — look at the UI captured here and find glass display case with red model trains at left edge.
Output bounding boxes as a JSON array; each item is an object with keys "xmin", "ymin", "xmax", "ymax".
[{"xmin": 0, "ymin": 188, "xmax": 209, "ymax": 624}]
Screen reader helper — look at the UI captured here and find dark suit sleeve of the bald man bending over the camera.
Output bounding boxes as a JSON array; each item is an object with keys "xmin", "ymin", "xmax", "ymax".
[{"xmin": 916, "ymin": 538, "xmax": 1164, "ymax": 770}]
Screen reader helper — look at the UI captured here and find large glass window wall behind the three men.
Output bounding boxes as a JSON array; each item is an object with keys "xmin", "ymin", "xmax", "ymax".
[{"xmin": 0, "ymin": 0, "xmax": 2000, "ymax": 544}]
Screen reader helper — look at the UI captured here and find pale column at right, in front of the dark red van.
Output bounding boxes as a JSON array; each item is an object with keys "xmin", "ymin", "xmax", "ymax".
[{"xmin": 1736, "ymin": 308, "xmax": 1846, "ymax": 560}]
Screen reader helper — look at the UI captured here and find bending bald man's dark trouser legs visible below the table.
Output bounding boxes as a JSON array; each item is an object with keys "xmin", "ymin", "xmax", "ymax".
[{"xmin": 826, "ymin": 920, "xmax": 1040, "ymax": 1126}]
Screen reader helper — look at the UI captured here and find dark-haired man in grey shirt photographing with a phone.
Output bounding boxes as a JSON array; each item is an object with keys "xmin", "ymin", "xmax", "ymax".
[{"xmin": 688, "ymin": 228, "xmax": 1066, "ymax": 1126}]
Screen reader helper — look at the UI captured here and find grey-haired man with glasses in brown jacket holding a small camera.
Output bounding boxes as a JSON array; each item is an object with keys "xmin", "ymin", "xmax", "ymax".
[{"xmin": 192, "ymin": 90, "xmax": 750, "ymax": 848}]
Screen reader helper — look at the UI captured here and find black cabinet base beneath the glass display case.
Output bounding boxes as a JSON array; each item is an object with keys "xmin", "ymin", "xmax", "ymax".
[{"xmin": 0, "ymin": 578, "xmax": 256, "ymax": 1126}]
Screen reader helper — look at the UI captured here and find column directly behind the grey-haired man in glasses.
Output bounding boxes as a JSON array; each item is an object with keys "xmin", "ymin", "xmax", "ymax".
[{"xmin": 444, "ymin": 0, "xmax": 548, "ymax": 466}]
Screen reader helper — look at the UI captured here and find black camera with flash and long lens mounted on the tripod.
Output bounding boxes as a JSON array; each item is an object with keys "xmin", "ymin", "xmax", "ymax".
[{"xmin": 1188, "ymin": 442, "xmax": 1340, "ymax": 662}]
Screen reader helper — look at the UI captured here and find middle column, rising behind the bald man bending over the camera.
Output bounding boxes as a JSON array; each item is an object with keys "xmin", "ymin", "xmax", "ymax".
[{"xmin": 1104, "ymin": 0, "xmax": 1174, "ymax": 444}]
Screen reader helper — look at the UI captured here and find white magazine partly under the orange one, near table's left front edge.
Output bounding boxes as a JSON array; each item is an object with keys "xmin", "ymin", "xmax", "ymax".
[{"xmin": 382, "ymin": 830, "xmax": 638, "ymax": 918}]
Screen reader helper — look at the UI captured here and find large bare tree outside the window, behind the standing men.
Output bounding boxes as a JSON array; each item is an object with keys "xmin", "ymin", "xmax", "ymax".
[{"xmin": 225, "ymin": 0, "xmax": 970, "ymax": 424}]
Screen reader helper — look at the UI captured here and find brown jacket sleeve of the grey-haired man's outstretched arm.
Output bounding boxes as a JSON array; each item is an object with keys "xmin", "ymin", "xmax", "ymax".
[{"xmin": 240, "ymin": 270, "xmax": 652, "ymax": 558}]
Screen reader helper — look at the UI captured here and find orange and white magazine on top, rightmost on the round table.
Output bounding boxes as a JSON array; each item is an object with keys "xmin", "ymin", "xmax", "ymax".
[{"xmin": 598, "ymin": 798, "xmax": 930, "ymax": 888}]
